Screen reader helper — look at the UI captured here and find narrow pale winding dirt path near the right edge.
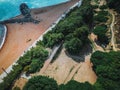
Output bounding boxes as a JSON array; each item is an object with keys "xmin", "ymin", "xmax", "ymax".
[{"xmin": 109, "ymin": 10, "xmax": 117, "ymax": 51}]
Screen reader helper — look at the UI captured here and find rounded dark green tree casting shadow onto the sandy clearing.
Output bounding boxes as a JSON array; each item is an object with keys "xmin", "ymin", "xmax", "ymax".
[{"xmin": 65, "ymin": 26, "xmax": 89, "ymax": 54}]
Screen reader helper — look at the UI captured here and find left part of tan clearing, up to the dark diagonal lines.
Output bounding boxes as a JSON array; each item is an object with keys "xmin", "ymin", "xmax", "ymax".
[{"xmin": 35, "ymin": 49, "xmax": 78, "ymax": 84}]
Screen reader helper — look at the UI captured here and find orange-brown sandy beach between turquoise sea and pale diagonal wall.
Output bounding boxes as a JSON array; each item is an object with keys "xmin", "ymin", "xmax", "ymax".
[{"xmin": 0, "ymin": 0, "xmax": 79, "ymax": 74}]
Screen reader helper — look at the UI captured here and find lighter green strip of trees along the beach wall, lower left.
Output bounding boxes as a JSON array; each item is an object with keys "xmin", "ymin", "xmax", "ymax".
[{"xmin": 0, "ymin": 45, "xmax": 48, "ymax": 90}]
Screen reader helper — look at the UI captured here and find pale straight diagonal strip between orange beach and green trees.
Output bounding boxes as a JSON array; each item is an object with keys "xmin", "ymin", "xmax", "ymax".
[{"xmin": 0, "ymin": 0, "xmax": 79, "ymax": 80}]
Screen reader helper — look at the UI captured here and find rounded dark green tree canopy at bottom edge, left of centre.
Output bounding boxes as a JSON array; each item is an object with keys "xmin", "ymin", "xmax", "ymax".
[{"xmin": 23, "ymin": 76, "xmax": 58, "ymax": 90}]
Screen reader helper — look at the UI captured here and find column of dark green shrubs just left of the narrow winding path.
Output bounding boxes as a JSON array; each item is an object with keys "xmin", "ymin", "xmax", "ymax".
[{"xmin": 92, "ymin": 0, "xmax": 110, "ymax": 46}]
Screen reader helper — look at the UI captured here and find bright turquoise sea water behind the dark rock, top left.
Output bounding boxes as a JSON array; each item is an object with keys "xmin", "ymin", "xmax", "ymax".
[{"xmin": 0, "ymin": 0, "xmax": 69, "ymax": 21}]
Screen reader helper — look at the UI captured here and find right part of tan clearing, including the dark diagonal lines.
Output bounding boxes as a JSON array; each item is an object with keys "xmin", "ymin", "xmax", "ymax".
[{"xmin": 64, "ymin": 55, "xmax": 97, "ymax": 84}]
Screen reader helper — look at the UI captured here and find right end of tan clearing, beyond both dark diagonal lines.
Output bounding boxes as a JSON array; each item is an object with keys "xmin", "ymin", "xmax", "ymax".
[{"xmin": 73, "ymin": 55, "xmax": 97, "ymax": 84}]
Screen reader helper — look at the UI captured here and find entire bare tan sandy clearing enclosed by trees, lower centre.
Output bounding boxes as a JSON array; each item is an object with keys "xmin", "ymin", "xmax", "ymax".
[{"xmin": 34, "ymin": 49, "xmax": 97, "ymax": 84}]
